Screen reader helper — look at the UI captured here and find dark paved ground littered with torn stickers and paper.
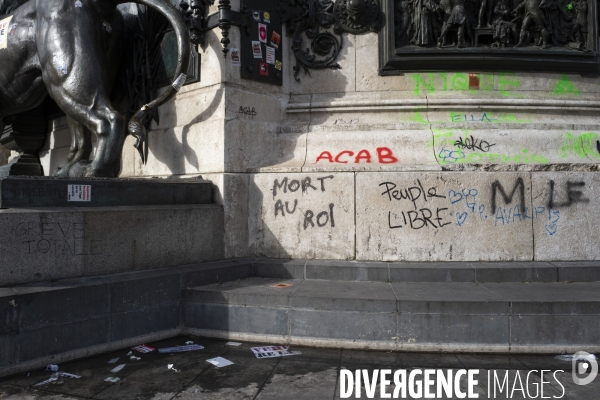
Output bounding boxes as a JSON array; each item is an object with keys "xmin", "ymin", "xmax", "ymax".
[{"xmin": 0, "ymin": 336, "xmax": 600, "ymax": 400}]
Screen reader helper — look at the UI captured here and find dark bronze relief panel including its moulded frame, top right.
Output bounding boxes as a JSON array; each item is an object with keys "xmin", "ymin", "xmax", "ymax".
[{"xmin": 380, "ymin": 0, "xmax": 598, "ymax": 75}]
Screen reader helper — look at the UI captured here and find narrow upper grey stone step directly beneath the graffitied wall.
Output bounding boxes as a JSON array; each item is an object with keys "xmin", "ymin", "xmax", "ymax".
[{"xmin": 248, "ymin": 259, "xmax": 600, "ymax": 282}]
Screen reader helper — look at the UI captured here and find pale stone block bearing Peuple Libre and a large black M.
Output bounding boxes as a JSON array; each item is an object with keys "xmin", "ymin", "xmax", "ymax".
[{"xmin": 356, "ymin": 172, "xmax": 541, "ymax": 261}]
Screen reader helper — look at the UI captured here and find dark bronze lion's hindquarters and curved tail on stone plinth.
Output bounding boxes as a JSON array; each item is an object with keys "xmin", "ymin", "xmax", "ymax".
[{"xmin": 0, "ymin": 0, "xmax": 190, "ymax": 177}]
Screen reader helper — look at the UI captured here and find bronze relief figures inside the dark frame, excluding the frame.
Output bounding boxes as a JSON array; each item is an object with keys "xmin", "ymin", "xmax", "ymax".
[{"xmin": 395, "ymin": 0, "xmax": 591, "ymax": 51}]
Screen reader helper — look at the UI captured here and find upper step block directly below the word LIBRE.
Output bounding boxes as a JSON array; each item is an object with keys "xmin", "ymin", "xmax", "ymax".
[{"xmin": 389, "ymin": 262, "xmax": 475, "ymax": 282}]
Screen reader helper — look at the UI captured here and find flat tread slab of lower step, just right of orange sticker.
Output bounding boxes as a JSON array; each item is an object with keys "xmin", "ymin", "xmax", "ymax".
[{"xmin": 290, "ymin": 280, "xmax": 396, "ymax": 313}]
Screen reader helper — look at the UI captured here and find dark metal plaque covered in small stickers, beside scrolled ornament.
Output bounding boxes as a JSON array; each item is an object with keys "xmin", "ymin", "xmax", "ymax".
[{"xmin": 240, "ymin": 0, "xmax": 284, "ymax": 86}]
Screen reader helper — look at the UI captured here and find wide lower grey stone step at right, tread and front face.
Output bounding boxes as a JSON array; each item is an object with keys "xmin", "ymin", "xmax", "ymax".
[{"xmin": 183, "ymin": 278, "xmax": 600, "ymax": 354}]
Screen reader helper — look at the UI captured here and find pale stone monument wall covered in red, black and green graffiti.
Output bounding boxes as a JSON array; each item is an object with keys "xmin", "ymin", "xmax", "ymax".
[{"xmin": 38, "ymin": 2, "xmax": 600, "ymax": 261}]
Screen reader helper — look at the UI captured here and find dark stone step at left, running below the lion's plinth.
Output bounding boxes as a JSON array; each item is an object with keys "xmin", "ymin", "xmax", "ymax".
[{"xmin": 0, "ymin": 259, "xmax": 252, "ymax": 376}]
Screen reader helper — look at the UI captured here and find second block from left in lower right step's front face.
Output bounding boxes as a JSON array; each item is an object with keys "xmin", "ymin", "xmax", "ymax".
[{"xmin": 289, "ymin": 309, "xmax": 397, "ymax": 342}]
